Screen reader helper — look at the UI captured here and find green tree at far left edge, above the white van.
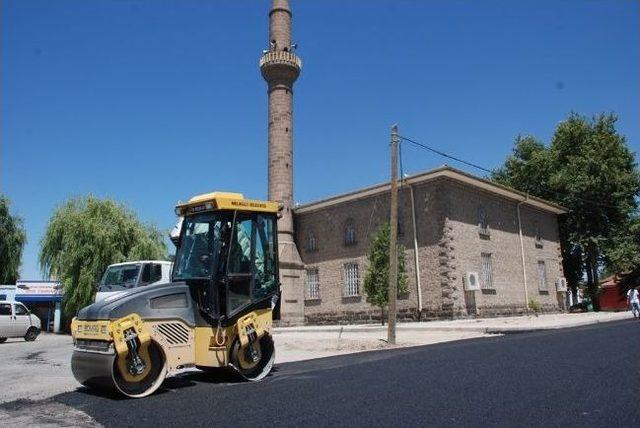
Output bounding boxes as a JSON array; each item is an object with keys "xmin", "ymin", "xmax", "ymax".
[{"xmin": 0, "ymin": 195, "xmax": 27, "ymax": 284}]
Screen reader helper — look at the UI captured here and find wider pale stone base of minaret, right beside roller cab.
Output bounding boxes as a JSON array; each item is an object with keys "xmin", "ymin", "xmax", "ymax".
[{"xmin": 278, "ymin": 241, "xmax": 305, "ymax": 326}]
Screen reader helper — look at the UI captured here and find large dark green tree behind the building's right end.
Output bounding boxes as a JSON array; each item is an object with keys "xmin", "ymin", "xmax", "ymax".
[{"xmin": 492, "ymin": 113, "xmax": 640, "ymax": 302}]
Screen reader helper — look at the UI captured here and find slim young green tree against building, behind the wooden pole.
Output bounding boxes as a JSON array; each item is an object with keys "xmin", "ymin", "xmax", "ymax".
[{"xmin": 364, "ymin": 223, "xmax": 407, "ymax": 325}]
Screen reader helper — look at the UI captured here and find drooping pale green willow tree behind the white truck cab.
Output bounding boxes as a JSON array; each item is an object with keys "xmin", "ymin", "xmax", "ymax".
[{"xmin": 40, "ymin": 196, "xmax": 167, "ymax": 314}]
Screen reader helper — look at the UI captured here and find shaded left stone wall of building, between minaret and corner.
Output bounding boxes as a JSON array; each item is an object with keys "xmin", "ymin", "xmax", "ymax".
[{"xmin": 295, "ymin": 189, "xmax": 424, "ymax": 324}]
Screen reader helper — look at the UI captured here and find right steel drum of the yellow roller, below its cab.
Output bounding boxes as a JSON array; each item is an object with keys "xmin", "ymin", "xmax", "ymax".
[{"xmin": 231, "ymin": 334, "xmax": 276, "ymax": 381}]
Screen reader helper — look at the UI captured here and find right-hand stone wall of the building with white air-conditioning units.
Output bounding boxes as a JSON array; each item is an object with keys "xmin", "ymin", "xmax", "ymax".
[{"xmin": 447, "ymin": 183, "xmax": 562, "ymax": 316}]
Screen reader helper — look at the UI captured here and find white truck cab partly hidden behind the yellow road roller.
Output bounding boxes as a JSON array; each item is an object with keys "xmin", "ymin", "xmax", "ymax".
[{"xmin": 95, "ymin": 260, "xmax": 173, "ymax": 302}]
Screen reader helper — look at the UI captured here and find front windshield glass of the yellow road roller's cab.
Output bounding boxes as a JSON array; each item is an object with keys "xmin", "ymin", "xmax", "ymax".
[{"xmin": 173, "ymin": 212, "xmax": 233, "ymax": 281}]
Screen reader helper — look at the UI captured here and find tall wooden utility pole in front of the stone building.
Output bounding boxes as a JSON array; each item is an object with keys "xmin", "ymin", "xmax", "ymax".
[{"xmin": 387, "ymin": 125, "xmax": 399, "ymax": 345}]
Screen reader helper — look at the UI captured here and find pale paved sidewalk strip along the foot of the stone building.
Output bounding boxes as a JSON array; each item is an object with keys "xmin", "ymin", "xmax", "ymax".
[{"xmin": 275, "ymin": 311, "xmax": 633, "ymax": 336}]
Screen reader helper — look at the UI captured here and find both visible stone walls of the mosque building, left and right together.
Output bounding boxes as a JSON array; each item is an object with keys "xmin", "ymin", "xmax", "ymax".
[{"xmin": 294, "ymin": 178, "xmax": 562, "ymax": 324}]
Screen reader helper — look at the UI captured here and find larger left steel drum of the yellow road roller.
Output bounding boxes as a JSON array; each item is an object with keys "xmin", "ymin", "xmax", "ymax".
[{"xmin": 71, "ymin": 342, "xmax": 167, "ymax": 398}]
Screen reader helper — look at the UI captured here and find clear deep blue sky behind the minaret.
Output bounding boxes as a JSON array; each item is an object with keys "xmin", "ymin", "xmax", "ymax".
[{"xmin": 0, "ymin": 0, "xmax": 640, "ymax": 279}]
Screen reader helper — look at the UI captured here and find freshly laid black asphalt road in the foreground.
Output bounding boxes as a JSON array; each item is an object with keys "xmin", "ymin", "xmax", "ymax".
[{"xmin": 54, "ymin": 320, "xmax": 640, "ymax": 427}]
